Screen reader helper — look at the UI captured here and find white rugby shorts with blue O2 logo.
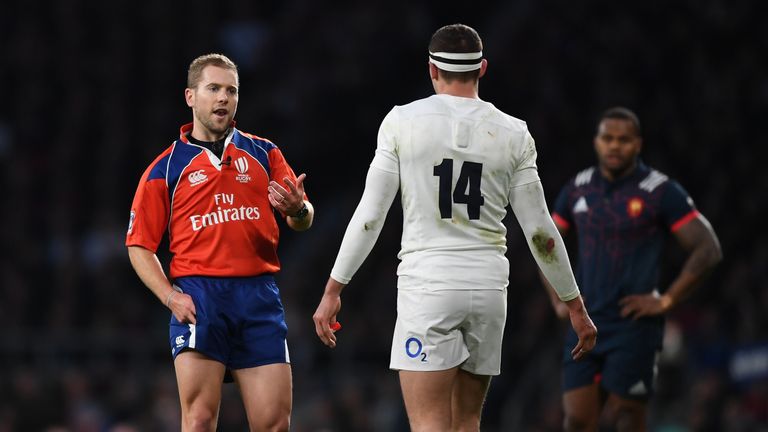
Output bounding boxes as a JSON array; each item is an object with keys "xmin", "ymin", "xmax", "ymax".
[{"xmin": 389, "ymin": 288, "xmax": 507, "ymax": 375}]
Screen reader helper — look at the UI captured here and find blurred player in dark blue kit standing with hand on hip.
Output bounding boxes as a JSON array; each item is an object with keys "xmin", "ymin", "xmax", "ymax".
[{"xmin": 544, "ymin": 107, "xmax": 722, "ymax": 431}]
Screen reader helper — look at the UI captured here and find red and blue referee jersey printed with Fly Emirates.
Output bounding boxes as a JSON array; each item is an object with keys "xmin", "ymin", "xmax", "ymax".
[{"xmin": 125, "ymin": 123, "xmax": 306, "ymax": 278}]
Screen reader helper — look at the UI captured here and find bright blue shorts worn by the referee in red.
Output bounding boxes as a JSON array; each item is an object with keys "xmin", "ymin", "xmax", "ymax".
[{"xmin": 169, "ymin": 275, "xmax": 290, "ymax": 369}]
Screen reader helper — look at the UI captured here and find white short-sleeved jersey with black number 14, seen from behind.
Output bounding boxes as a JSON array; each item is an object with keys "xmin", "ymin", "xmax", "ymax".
[{"xmin": 371, "ymin": 94, "xmax": 539, "ymax": 289}]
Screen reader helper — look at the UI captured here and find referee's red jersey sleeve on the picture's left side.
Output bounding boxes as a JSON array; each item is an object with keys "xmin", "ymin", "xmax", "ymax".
[{"xmin": 125, "ymin": 164, "xmax": 170, "ymax": 252}]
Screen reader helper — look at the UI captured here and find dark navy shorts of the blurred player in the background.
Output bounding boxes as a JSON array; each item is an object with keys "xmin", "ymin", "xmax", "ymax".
[{"xmin": 563, "ymin": 325, "xmax": 661, "ymax": 401}]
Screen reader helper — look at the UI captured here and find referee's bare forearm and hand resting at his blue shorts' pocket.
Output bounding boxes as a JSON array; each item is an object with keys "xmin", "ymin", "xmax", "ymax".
[{"xmin": 128, "ymin": 245, "xmax": 196, "ymax": 324}]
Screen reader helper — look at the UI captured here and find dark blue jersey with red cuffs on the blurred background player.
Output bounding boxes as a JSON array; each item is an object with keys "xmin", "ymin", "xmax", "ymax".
[{"xmin": 552, "ymin": 163, "xmax": 698, "ymax": 322}]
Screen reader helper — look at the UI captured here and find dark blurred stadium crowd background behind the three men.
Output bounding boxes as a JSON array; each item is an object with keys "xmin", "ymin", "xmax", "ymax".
[{"xmin": 0, "ymin": 0, "xmax": 768, "ymax": 432}]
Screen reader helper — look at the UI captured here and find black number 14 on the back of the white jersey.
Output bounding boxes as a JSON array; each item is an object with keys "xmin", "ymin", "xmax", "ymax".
[{"xmin": 433, "ymin": 159, "xmax": 485, "ymax": 220}]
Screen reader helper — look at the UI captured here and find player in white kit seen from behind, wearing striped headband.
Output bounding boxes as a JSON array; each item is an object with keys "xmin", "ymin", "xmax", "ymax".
[{"xmin": 313, "ymin": 24, "xmax": 597, "ymax": 431}]
